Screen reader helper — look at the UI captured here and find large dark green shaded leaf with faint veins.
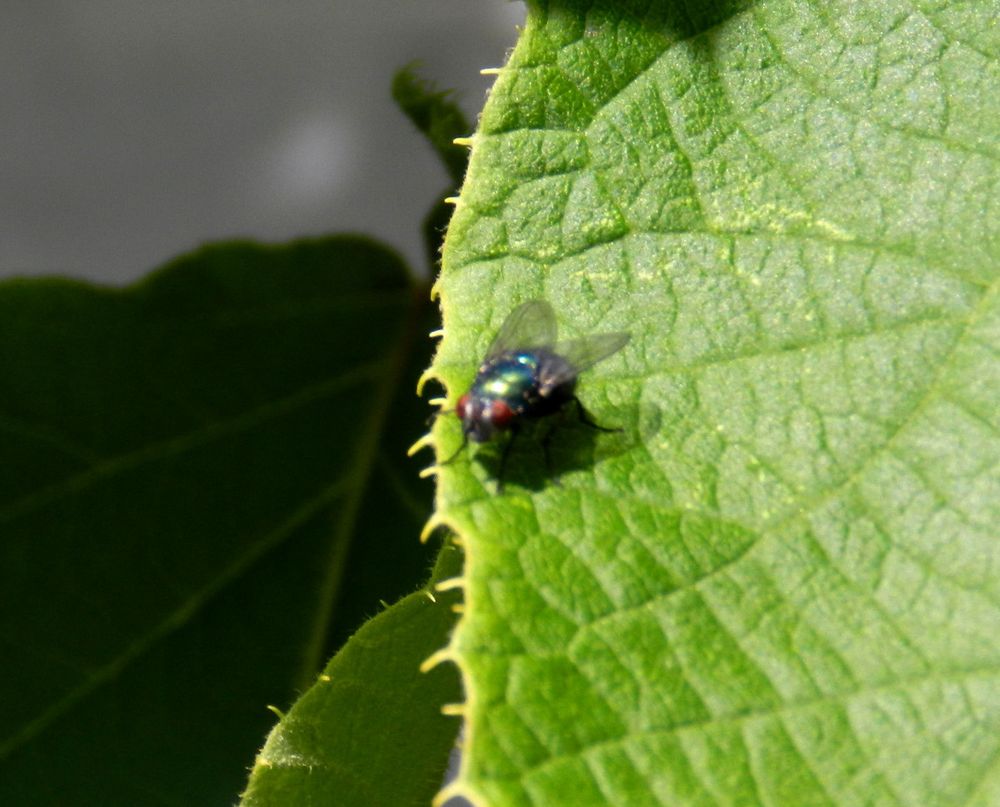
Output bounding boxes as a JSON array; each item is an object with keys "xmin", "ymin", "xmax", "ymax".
[{"xmin": 0, "ymin": 238, "xmax": 446, "ymax": 807}]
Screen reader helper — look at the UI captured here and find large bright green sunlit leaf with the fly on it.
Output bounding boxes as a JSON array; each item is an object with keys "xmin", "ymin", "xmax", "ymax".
[{"xmin": 434, "ymin": 0, "xmax": 1000, "ymax": 807}]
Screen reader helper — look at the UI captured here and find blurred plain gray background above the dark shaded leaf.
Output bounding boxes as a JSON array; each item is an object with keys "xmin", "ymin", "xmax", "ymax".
[{"xmin": 0, "ymin": 0, "xmax": 525, "ymax": 284}]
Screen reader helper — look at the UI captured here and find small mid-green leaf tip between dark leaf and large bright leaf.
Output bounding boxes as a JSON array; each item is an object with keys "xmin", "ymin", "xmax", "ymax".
[{"xmin": 242, "ymin": 547, "xmax": 462, "ymax": 807}]
